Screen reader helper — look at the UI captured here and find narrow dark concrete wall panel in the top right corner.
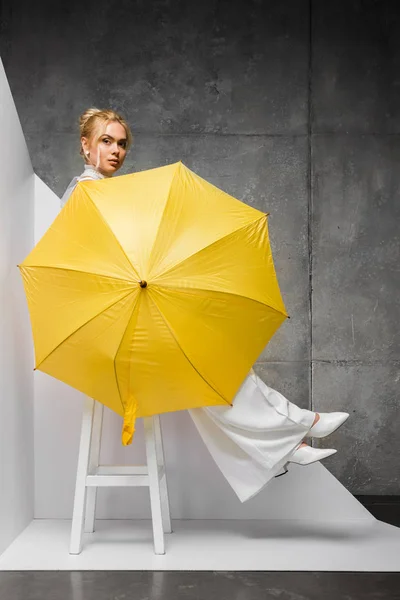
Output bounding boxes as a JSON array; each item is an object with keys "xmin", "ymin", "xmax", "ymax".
[{"xmin": 312, "ymin": 0, "xmax": 400, "ymax": 134}]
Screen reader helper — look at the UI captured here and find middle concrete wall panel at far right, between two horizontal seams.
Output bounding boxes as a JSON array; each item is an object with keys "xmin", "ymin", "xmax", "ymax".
[{"xmin": 312, "ymin": 135, "xmax": 400, "ymax": 360}]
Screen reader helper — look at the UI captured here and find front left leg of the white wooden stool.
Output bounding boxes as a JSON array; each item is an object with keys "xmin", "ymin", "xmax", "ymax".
[{"xmin": 69, "ymin": 396, "xmax": 95, "ymax": 554}]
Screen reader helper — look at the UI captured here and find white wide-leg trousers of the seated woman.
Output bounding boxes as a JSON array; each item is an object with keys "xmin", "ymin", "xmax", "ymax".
[{"xmin": 189, "ymin": 371, "xmax": 315, "ymax": 502}]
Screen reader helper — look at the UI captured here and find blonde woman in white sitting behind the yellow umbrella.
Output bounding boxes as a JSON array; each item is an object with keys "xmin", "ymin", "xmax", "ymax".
[{"xmin": 61, "ymin": 108, "xmax": 349, "ymax": 502}]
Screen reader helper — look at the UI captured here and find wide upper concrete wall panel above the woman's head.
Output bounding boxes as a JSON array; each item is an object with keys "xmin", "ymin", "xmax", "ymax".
[{"xmin": 3, "ymin": 0, "xmax": 309, "ymax": 136}]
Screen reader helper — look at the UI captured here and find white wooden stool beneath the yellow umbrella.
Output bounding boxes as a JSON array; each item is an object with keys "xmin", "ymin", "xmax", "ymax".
[{"xmin": 69, "ymin": 396, "xmax": 172, "ymax": 554}]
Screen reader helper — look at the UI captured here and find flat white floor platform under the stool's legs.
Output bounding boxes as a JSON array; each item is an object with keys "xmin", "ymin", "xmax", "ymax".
[{"xmin": 0, "ymin": 519, "xmax": 400, "ymax": 571}]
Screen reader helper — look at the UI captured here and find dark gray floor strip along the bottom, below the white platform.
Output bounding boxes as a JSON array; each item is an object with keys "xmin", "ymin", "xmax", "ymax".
[{"xmin": 0, "ymin": 571, "xmax": 400, "ymax": 600}]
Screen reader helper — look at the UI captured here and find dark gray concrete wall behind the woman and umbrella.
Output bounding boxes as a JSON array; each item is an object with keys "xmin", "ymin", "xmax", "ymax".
[{"xmin": 0, "ymin": 0, "xmax": 400, "ymax": 494}]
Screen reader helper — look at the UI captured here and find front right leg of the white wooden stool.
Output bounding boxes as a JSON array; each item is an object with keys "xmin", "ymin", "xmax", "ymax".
[{"xmin": 143, "ymin": 417, "xmax": 165, "ymax": 554}]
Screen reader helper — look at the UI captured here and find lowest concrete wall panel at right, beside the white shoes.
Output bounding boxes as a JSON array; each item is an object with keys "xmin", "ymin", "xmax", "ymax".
[{"xmin": 313, "ymin": 361, "xmax": 400, "ymax": 494}]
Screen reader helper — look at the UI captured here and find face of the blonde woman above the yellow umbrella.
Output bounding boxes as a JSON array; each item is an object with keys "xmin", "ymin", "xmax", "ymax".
[{"xmin": 81, "ymin": 121, "xmax": 127, "ymax": 176}]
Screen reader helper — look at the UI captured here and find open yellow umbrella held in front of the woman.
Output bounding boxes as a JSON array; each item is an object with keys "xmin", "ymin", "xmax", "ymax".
[{"xmin": 19, "ymin": 162, "xmax": 288, "ymax": 445}]
